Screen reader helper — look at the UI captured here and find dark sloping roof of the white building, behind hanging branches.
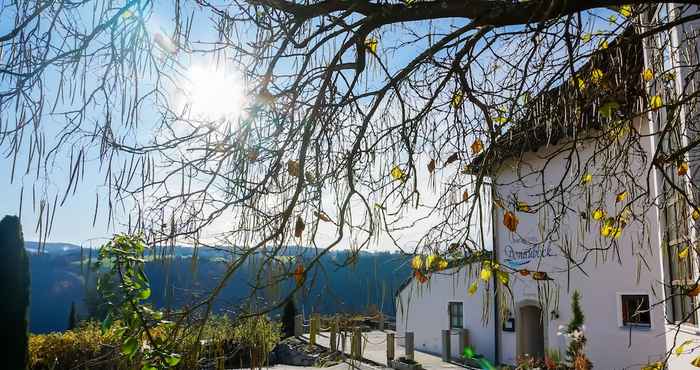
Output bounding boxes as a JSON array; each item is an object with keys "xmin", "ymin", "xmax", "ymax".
[{"xmin": 470, "ymin": 28, "xmax": 646, "ymax": 173}]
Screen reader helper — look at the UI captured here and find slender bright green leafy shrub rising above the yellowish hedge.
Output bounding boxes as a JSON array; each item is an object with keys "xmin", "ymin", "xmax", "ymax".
[{"xmin": 95, "ymin": 235, "xmax": 181, "ymax": 369}]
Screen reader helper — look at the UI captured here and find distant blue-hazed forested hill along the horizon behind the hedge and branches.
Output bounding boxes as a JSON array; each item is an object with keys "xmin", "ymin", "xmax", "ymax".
[{"xmin": 25, "ymin": 242, "xmax": 410, "ymax": 333}]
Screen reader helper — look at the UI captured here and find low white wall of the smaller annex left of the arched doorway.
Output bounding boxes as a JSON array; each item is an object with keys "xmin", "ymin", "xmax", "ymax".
[{"xmin": 396, "ymin": 265, "xmax": 495, "ymax": 361}]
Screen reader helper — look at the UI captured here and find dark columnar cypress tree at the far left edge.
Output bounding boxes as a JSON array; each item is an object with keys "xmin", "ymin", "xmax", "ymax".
[{"xmin": 0, "ymin": 216, "xmax": 29, "ymax": 369}]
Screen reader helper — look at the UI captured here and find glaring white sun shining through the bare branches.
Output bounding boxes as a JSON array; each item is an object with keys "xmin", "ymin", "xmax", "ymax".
[{"xmin": 179, "ymin": 65, "xmax": 247, "ymax": 121}]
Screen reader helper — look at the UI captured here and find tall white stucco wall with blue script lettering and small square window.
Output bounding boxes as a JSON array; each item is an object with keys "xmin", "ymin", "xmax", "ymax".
[{"xmin": 494, "ymin": 120, "xmax": 666, "ymax": 370}]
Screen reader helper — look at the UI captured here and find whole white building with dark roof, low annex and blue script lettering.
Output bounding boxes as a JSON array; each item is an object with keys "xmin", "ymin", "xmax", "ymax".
[{"xmin": 396, "ymin": 5, "xmax": 700, "ymax": 370}]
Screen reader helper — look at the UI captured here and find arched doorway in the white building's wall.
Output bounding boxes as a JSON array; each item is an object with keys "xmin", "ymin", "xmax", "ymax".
[{"xmin": 516, "ymin": 304, "xmax": 545, "ymax": 358}]
